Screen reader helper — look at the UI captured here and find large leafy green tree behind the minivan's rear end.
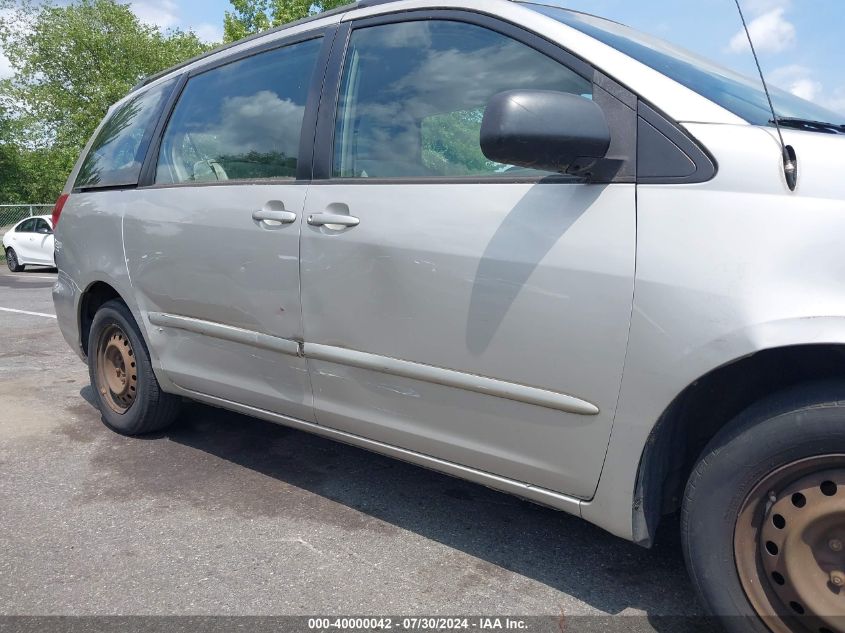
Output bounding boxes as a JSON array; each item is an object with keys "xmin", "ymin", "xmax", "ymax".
[{"xmin": 0, "ymin": 0, "xmax": 209, "ymax": 200}]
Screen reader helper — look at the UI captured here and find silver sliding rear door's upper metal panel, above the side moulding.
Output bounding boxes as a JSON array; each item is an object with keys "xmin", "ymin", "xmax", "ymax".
[{"xmin": 126, "ymin": 185, "xmax": 305, "ymax": 338}]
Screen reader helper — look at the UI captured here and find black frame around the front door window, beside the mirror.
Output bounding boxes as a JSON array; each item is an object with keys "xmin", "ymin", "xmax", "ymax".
[{"xmin": 313, "ymin": 9, "xmax": 637, "ymax": 185}]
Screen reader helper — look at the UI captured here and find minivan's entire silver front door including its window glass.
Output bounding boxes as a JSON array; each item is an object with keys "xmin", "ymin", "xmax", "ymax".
[{"xmin": 302, "ymin": 18, "xmax": 635, "ymax": 498}]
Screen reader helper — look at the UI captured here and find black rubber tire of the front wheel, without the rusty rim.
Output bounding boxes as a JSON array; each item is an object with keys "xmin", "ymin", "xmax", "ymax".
[{"xmin": 681, "ymin": 381, "xmax": 845, "ymax": 633}]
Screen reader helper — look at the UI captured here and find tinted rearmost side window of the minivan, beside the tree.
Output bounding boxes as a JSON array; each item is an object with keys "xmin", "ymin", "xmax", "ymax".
[{"xmin": 75, "ymin": 79, "xmax": 176, "ymax": 189}]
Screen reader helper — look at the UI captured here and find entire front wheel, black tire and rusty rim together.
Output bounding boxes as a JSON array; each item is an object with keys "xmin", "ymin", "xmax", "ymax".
[{"xmin": 681, "ymin": 383, "xmax": 845, "ymax": 633}]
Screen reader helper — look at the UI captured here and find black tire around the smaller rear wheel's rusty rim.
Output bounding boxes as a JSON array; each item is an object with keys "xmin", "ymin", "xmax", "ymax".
[{"xmin": 88, "ymin": 301, "xmax": 157, "ymax": 435}]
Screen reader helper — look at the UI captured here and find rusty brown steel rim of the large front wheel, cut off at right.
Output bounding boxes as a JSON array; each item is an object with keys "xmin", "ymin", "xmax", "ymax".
[{"xmin": 734, "ymin": 455, "xmax": 845, "ymax": 633}]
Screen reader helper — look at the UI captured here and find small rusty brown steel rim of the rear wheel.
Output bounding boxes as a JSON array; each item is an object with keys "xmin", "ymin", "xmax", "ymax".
[{"xmin": 96, "ymin": 324, "xmax": 138, "ymax": 414}]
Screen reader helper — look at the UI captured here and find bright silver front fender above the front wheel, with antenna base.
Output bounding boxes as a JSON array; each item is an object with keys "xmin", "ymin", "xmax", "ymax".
[{"xmin": 582, "ymin": 125, "xmax": 845, "ymax": 538}]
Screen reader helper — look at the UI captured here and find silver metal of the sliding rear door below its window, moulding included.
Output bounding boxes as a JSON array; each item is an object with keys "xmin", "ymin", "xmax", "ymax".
[{"xmin": 124, "ymin": 181, "xmax": 314, "ymax": 420}]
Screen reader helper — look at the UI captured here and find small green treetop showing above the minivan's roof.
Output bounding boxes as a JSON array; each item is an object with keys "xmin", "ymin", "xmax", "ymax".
[{"xmin": 223, "ymin": 0, "xmax": 350, "ymax": 42}]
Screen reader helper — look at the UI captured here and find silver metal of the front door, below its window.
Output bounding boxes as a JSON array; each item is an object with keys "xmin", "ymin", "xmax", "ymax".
[{"xmin": 301, "ymin": 180, "xmax": 636, "ymax": 498}]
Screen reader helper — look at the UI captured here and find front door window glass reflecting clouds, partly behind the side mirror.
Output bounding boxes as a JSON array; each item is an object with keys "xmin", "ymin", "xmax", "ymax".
[{"xmin": 336, "ymin": 21, "xmax": 592, "ymax": 177}]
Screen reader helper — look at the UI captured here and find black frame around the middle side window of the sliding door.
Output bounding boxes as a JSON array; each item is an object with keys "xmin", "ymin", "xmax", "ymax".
[{"xmin": 138, "ymin": 24, "xmax": 338, "ymax": 189}]
